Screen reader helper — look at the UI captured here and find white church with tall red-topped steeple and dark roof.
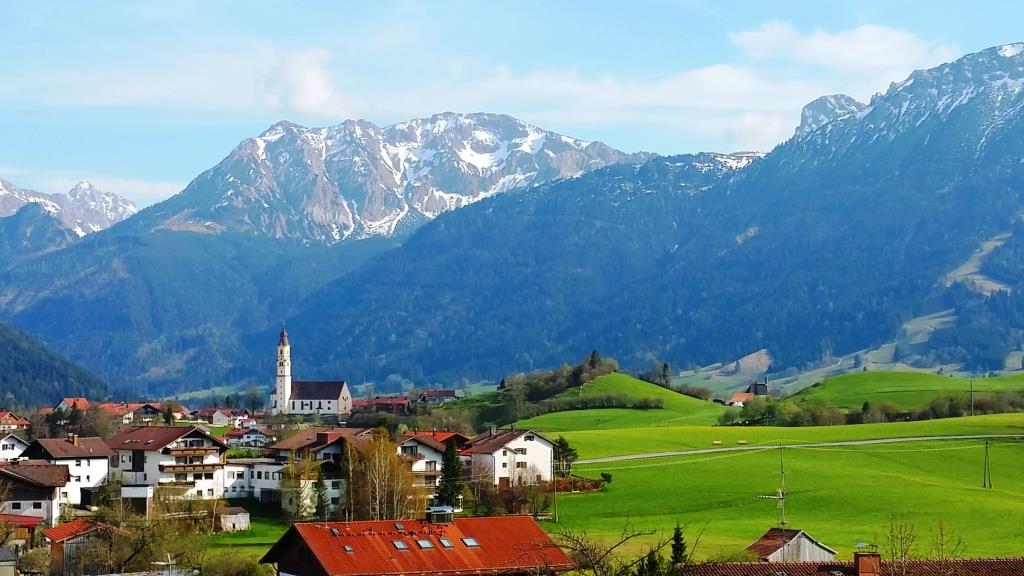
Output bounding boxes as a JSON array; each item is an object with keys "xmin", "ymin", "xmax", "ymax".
[{"xmin": 269, "ymin": 328, "xmax": 352, "ymax": 416}]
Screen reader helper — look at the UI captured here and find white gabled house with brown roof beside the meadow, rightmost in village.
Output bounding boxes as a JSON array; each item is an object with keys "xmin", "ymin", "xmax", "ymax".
[{"xmin": 463, "ymin": 428, "xmax": 554, "ymax": 486}]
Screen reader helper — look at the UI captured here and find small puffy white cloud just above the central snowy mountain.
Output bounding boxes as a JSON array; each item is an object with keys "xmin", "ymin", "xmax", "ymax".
[{"xmin": 266, "ymin": 49, "xmax": 362, "ymax": 118}]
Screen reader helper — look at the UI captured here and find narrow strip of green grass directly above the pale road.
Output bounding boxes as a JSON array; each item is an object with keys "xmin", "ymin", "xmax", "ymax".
[{"xmin": 552, "ymin": 414, "xmax": 1024, "ymax": 458}]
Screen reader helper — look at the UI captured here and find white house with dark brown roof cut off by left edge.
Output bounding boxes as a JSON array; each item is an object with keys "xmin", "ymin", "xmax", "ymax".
[{"xmin": 0, "ymin": 460, "xmax": 71, "ymax": 526}]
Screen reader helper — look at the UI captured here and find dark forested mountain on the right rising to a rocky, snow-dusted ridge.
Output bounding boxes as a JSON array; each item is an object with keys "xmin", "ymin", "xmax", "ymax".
[{"xmin": 276, "ymin": 40, "xmax": 1024, "ymax": 381}]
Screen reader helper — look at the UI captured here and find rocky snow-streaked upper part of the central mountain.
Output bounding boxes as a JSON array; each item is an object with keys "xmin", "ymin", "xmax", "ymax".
[{"xmin": 141, "ymin": 113, "xmax": 649, "ymax": 244}]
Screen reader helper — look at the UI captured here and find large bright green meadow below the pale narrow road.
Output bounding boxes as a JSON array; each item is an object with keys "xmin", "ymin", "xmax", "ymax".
[{"xmin": 548, "ymin": 436, "xmax": 1024, "ymax": 559}]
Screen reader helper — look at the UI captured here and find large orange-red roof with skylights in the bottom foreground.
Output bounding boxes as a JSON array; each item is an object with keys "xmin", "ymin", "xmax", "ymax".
[{"xmin": 260, "ymin": 516, "xmax": 573, "ymax": 576}]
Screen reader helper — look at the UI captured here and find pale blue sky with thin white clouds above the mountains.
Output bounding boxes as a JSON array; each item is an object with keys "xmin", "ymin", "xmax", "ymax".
[{"xmin": 0, "ymin": 0, "xmax": 1024, "ymax": 206}]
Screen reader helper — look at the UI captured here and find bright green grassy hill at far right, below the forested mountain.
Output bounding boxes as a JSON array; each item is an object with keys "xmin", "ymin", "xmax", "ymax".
[{"xmin": 793, "ymin": 372, "xmax": 1024, "ymax": 410}]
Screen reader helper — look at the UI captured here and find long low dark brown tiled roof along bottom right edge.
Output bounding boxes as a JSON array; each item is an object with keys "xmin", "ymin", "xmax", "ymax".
[{"xmin": 678, "ymin": 558, "xmax": 1024, "ymax": 576}]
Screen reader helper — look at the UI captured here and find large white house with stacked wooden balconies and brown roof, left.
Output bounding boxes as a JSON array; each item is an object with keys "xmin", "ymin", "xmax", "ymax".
[{"xmin": 106, "ymin": 426, "xmax": 227, "ymax": 513}]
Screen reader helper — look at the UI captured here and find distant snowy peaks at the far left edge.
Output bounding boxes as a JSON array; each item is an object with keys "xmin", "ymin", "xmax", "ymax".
[{"xmin": 0, "ymin": 178, "xmax": 138, "ymax": 237}]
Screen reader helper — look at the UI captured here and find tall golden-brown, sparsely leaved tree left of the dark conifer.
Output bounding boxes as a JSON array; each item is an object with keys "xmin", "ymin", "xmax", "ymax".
[{"xmin": 349, "ymin": 428, "xmax": 425, "ymax": 520}]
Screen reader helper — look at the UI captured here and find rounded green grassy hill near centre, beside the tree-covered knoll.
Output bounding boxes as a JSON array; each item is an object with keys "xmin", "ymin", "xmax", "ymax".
[{"xmin": 516, "ymin": 373, "xmax": 725, "ymax": 431}]
